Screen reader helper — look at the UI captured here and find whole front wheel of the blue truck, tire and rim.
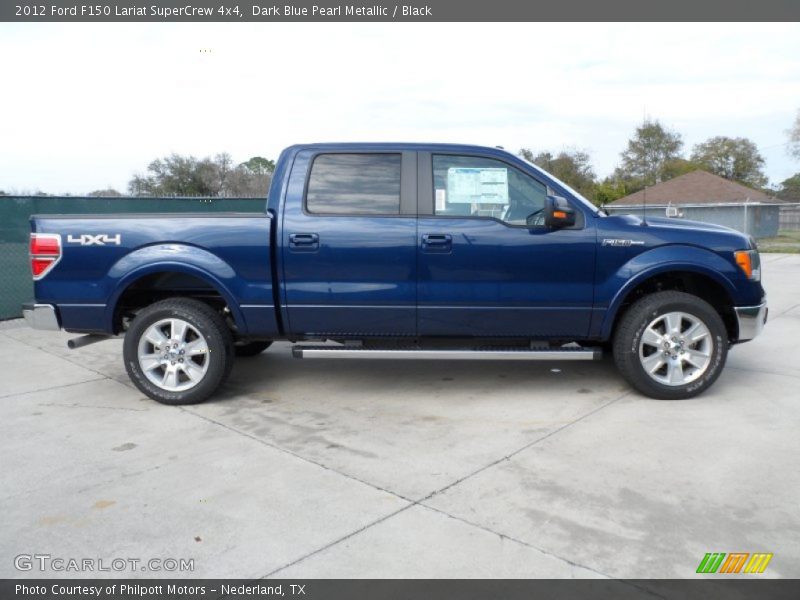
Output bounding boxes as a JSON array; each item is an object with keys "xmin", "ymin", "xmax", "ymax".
[{"xmin": 614, "ymin": 292, "xmax": 728, "ymax": 400}]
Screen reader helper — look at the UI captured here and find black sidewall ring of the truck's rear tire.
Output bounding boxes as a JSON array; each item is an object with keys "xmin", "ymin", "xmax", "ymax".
[{"xmin": 123, "ymin": 303, "xmax": 229, "ymax": 405}]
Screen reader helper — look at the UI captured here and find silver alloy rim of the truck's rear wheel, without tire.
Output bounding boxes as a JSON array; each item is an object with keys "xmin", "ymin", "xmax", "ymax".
[{"xmin": 138, "ymin": 319, "xmax": 211, "ymax": 392}]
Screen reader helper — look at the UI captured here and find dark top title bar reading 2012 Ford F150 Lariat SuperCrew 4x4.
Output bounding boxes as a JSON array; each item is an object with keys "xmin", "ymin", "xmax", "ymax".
[{"xmin": 0, "ymin": 0, "xmax": 800, "ymax": 22}]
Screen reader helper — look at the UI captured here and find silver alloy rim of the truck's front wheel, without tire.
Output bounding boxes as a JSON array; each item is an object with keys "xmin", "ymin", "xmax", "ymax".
[{"xmin": 639, "ymin": 312, "xmax": 714, "ymax": 386}]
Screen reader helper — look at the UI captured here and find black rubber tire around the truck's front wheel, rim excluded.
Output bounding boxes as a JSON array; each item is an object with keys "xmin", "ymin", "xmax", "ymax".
[{"xmin": 614, "ymin": 291, "xmax": 729, "ymax": 400}]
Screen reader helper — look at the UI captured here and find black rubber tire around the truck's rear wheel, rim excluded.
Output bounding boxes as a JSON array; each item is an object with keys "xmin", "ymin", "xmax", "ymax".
[{"xmin": 123, "ymin": 298, "xmax": 233, "ymax": 405}]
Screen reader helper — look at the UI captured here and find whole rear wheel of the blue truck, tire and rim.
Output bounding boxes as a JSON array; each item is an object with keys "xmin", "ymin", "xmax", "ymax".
[{"xmin": 123, "ymin": 298, "xmax": 233, "ymax": 405}]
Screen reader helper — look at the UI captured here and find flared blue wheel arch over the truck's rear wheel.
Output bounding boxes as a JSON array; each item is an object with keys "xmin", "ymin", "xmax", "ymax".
[{"xmin": 104, "ymin": 244, "xmax": 245, "ymax": 331}]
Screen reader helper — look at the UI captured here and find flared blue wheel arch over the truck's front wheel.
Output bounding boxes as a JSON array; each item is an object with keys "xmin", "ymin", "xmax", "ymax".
[{"xmin": 595, "ymin": 245, "xmax": 742, "ymax": 339}]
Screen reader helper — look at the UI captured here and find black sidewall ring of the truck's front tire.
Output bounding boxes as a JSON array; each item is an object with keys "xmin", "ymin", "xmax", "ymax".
[{"xmin": 622, "ymin": 294, "xmax": 728, "ymax": 400}]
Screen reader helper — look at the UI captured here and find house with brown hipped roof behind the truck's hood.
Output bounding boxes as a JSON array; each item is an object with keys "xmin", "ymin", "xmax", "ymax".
[{"xmin": 606, "ymin": 170, "xmax": 781, "ymax": 238}]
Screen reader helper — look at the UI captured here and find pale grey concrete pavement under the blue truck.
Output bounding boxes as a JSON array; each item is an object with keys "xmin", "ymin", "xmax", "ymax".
[{"xmin": 0, "ymin": 254, "xmax": 800, "ymax": 578}]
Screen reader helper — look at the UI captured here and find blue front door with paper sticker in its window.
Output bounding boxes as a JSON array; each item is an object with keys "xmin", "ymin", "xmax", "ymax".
[{"xmin": 417, "ymin": 153, "xmax": 596, "ymax": 338}]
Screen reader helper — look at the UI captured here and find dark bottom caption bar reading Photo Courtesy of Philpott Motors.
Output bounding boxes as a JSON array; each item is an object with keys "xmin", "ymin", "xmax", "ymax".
[{"xmin": 0, "ymin": 576, "xmax": 800, "ymax": 600}]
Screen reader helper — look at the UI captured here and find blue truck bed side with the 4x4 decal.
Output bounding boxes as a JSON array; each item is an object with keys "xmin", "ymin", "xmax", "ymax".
[{"xmin": 31, "ymin": 213, "xmax": 277, "ymax": 335}]
